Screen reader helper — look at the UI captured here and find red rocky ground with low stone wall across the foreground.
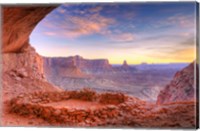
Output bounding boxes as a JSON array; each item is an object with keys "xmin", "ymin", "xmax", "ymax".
[{"xmin": 3, "ymin": 93, "xmax": 195, "ymax": 128}]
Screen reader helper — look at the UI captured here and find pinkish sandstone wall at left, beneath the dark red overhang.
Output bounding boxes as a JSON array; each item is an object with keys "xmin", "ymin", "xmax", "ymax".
[{"xmin": 2, "ymin": 46, "xmax": 60, "ymax": 101}]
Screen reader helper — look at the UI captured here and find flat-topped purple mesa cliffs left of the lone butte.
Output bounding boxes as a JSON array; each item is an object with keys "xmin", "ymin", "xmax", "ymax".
[{"xmin": 44, "ymin": 56, "xmax": 112, "ymax": 75}]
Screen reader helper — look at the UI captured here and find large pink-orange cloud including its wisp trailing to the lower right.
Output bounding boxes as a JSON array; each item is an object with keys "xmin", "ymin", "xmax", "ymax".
[{"xmin": 41, "ymin": 12, "xmax": 135, "ymax": 42}]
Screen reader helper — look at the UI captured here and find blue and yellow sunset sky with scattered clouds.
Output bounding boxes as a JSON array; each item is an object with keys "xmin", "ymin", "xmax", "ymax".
[{"xmin": 30, "ymin": 2, "xmax": 196, "ymax": 64}]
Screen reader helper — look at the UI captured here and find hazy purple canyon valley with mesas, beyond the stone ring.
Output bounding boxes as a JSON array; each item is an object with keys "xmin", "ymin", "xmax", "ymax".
[{"xmin": 43, "ymin": 55, "xmax": 187, "ymax": 101}]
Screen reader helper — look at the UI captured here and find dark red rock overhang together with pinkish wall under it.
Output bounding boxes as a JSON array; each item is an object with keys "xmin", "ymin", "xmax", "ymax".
[{"xmin": 2, "ymin": 5, "xmax": 60, "ymax": 101}]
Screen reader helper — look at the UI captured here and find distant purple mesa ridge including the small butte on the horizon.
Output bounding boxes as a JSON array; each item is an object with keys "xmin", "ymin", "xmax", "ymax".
[{"xmin": 43, "ymin": 55, "xmax": 135, "ymax": 73}]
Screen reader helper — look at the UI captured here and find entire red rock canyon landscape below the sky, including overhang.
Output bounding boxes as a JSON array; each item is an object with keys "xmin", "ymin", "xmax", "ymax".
[{"xmin": 1, "ymin": 6, "xmax": 198, "ymax": 128}]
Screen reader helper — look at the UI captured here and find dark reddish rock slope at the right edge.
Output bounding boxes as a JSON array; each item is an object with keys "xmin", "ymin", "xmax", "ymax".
[{"xmin": 157, "ymin": 63, "xmax": 198, "ymax": 104}]
